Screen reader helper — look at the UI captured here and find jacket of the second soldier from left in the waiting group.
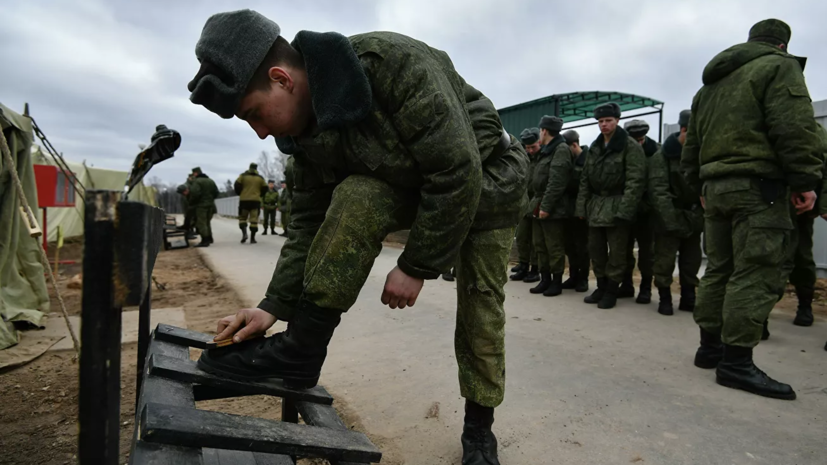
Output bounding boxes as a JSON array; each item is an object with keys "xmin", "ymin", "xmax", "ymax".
[{"xmin": 529, "ymin": 136, "xmax": 574, "ymax": 220}]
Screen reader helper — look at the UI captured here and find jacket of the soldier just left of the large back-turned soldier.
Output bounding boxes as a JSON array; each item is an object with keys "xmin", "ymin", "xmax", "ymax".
[{"xmin": 648, "ymin": 132, "xmax": 704, "ymax": 237}]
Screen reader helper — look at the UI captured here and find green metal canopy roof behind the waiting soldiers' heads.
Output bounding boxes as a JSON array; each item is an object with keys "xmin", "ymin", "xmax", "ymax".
[{"xmin": 497, "ymin": 90, "xmax": 663, "ymax": 136}]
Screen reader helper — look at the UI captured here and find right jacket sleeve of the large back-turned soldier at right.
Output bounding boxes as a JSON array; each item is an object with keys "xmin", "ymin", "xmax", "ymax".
[{"xmin": 763, "ymin": 59, "xmax": 823, "ymax": 192}]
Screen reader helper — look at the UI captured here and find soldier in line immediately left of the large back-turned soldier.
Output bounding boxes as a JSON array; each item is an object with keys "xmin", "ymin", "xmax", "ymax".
[{"xmin": 648, "ymin": 110, "xmax": 704, "ymax": 315}]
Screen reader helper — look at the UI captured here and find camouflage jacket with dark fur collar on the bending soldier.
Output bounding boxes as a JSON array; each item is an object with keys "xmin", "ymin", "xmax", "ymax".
[{"xmin": 260, "ymin": 31, "xmax": 528, "ymax": 313}]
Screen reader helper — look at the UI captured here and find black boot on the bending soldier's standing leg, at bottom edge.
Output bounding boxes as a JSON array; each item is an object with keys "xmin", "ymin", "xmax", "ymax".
[{"xmin": 461, "ymin": 400, "xmax": 500, "ymax": 465}]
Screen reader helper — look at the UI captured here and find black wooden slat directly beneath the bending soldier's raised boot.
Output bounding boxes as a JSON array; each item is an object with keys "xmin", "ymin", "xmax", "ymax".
[{"xmin": 149, "ymin": 356, "xmax": 333, "ymax": 405}]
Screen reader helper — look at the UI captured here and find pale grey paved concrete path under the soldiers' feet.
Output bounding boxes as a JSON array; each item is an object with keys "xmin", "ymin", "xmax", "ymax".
[{"xmin": 197, "ymin": 219, "xmax": 827, "ymax": 465}]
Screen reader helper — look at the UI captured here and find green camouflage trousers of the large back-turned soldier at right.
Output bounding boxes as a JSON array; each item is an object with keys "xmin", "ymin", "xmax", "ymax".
[{"xmin": 695, "ymin": 178, "xmax": 793, "ymax": 347}]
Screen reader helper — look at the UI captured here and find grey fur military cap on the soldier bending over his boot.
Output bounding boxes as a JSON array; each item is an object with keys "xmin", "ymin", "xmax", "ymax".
[{"xmin": 187, "ymin": 10, "xmax": 281, "ymax": 119}]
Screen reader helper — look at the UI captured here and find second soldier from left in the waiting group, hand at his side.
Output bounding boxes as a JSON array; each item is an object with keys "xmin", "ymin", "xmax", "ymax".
[{"xmin": 529, "ymin": 116, "xmax": 574, "ymax": 297}]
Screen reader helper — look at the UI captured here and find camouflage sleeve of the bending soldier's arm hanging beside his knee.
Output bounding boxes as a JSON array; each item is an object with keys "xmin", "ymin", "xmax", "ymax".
[{"xmin": 361, "ymin": 47, "xmax": 482, "ymax": 279}]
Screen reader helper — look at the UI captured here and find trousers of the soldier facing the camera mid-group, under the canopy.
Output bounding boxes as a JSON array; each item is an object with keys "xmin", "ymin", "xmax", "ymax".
[{"xmin": 589, "ymin": 224, "xmax": 632, "ymax": 283}]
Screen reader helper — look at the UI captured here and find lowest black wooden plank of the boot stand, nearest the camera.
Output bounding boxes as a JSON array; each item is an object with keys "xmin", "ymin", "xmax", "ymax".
[{"xmin": 140, "ymin": 404, "xmax": 382, "ymax": 462}]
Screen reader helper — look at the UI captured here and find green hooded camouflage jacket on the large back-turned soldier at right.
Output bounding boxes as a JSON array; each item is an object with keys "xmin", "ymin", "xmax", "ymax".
[{"xmin": 681, "ymin": 42, "xmax": 822, "ymax": 194}]
